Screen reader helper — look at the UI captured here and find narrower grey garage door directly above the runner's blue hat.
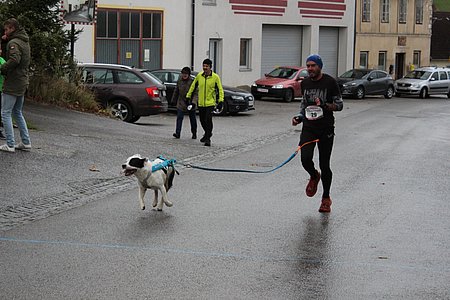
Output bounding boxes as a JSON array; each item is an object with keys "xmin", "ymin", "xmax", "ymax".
[{"xmin": 319, "ymin": 27, "xmax": 339, "ymax": 77}]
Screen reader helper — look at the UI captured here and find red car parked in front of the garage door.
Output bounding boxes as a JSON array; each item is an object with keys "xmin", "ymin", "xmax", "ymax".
[{"xmin": 252, "ymin": 66, "xmax": 308, "ymax": 102}]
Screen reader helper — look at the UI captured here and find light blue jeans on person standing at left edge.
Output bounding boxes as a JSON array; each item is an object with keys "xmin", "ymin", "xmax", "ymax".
[{"xmin": 1, "ymin": 93, "xmax": 31, "ymax": 147}]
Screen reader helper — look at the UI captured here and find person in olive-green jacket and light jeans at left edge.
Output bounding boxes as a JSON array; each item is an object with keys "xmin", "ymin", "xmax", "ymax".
[{"xmin": 0, "ymin": 18, "xmax": 31, "ymax": 152}]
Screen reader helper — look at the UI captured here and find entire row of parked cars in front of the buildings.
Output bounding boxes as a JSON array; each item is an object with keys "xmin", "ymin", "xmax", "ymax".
[{"xmin": 78, "ymin": 63, "xmax": 450, "ymax": 123}]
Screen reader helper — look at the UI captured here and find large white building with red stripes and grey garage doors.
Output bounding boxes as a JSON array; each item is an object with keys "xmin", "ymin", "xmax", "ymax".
[{"xmin": 62, "ymin": 0, "xmax": 355, "ymax": 86}]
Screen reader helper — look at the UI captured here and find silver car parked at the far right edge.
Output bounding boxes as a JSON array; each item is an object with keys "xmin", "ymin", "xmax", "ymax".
[{"xmin": 395, "ymin": 67, "xmax": 450, "ymax": 98}]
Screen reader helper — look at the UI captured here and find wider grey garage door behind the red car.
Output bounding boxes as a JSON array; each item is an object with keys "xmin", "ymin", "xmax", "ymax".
[{"xmin": 261, "ymin": 25, "xmax": 302, "ymax": 75}]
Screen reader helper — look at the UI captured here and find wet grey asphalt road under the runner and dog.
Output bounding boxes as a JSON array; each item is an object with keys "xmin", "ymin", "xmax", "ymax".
[{"xmin": 0, "ymin": 98, "xmax": 450, "ymax": 299}]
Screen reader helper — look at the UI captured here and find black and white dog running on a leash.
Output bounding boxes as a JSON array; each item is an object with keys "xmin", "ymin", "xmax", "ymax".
[{"xmin": 122, "ymin": 154, "xmax": 178, "ymax": 211}]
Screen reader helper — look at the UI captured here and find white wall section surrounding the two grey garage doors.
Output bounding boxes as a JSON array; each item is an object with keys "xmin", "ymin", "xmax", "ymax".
[{"xmin": 194, "ymin": 0, "xmax": 355, "ymax": 85}]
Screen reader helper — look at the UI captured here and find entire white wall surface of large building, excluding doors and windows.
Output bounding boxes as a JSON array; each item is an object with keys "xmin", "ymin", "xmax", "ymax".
[{"xmin": 68, "ymin": 0, "xmax": 355, "ymax": 86}]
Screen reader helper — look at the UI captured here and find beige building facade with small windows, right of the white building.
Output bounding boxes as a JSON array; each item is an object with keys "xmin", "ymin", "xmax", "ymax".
[{"xmin": 354, "ymin": 0, "xmax": 433, "ymax": 79}]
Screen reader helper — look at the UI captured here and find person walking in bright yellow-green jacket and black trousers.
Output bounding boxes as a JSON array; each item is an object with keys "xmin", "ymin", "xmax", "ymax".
[{"xmin": 186, "ymin": 58, "xmax": 224, "ymax": 146}]
